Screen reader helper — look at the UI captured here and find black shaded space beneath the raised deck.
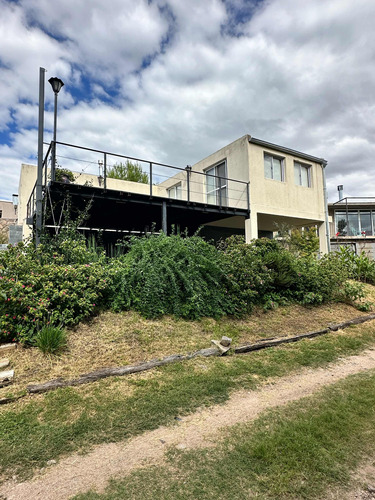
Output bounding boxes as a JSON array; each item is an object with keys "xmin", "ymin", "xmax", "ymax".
[{"xmin": 45, "ymin": 181, "xmax": 249, "ymax": 243}]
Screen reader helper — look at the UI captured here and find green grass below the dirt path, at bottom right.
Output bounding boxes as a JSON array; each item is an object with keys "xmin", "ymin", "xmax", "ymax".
[{"xmin": 75, "ymin": 371, "xmax": 375, "ymax": 500}]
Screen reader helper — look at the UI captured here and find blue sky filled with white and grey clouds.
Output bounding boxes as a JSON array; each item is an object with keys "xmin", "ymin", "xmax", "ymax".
[{"xmin": 0, "ymin": 0, "xmax": 375, "ymax": 202}]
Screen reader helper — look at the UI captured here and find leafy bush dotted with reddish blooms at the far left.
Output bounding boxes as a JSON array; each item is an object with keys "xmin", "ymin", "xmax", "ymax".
[{"xmin": 0, "ymin": 243, "xmax": 107, "ymax": 343}]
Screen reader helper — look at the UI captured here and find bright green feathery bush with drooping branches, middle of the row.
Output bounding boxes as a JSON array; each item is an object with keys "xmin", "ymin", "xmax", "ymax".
[{"xmin": 111, "ymin": 234, "xmax": 234, "ymax": 319}]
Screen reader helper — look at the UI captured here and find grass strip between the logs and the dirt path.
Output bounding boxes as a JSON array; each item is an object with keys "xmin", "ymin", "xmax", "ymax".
[{"xmin": 0, "ymin": 311, "xmax": 375, "ymax": 478}]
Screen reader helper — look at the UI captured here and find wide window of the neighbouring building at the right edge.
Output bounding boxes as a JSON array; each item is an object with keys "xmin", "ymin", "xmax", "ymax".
[{"xmin": 335, "ymin": 210, "xmax": 375, "ymax": 236}]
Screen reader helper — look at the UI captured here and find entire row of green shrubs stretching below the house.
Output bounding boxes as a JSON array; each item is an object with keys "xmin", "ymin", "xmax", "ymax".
[{"xmin": 0, "ymin": 226, "xmax": 375, "ymax": 343}]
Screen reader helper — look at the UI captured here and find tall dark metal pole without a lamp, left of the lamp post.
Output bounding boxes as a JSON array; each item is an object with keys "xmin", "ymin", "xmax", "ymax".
[{"xmin": 35, "ymin": 68, "xmax": 46, "ymax": 246}]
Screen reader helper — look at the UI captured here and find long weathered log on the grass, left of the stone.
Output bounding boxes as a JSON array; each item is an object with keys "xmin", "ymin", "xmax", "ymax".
[{"xmin": 26, "ymin": 347, "xmax": 221, "ymax": 394}]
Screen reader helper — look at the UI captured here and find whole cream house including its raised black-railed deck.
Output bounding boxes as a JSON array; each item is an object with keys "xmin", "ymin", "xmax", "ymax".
[{"xmin": 19, "ymin": 135, "xmax": 329, "ymax": 252}]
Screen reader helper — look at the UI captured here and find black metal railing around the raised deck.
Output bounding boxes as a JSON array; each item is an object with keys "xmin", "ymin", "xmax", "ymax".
[{"xmin": 27, "ymin": 141, "xmax": 250, "ymax": 225}]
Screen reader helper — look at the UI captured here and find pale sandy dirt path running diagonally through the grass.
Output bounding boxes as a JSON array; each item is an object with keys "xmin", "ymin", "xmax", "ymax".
[{"xmin": 0, "ymin": 350, "xmax": 375, "ymax": 500}]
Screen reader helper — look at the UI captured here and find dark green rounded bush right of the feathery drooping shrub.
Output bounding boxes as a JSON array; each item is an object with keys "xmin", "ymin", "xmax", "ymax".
[{"xmin": 221, "ymin": 236, "xmax": 347, "ymax": 311}]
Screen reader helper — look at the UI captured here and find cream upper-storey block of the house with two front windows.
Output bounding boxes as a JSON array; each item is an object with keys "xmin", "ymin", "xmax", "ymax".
[{"xmin": 169, "ymin": 135, "xmax": 329, "ymax": 253}]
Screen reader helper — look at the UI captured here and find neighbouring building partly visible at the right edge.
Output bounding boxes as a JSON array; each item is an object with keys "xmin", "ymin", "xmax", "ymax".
[{"xmin": 328, "ymin": 197, "xmax": 375, "ymax": 258}]
